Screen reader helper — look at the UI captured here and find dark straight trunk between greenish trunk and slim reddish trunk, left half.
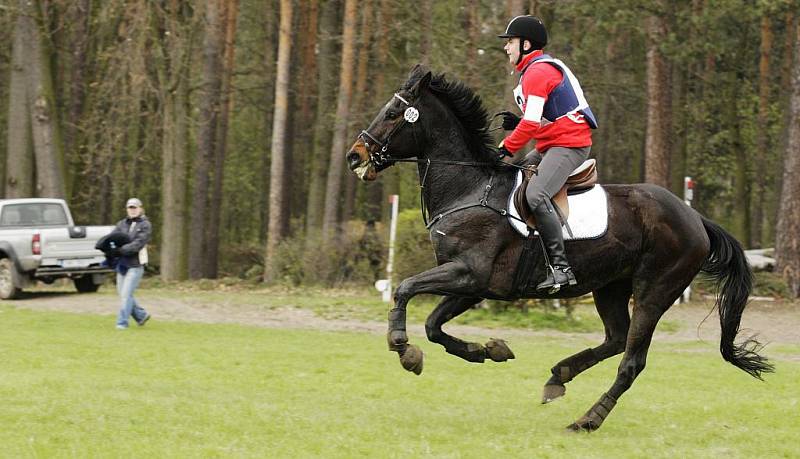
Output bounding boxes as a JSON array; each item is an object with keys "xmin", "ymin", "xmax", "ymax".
[{"xmin": 189, "ymin": 0, "xmax": 223, "ymax": 279}]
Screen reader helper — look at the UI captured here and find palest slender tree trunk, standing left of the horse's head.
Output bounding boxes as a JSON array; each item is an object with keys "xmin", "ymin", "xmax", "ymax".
[{"xmin": 264, "ymin": 0, "xmax": 292, "ymax": 281}]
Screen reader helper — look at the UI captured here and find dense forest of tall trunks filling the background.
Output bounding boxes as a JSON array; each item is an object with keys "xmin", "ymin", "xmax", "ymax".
[{"xmin": 0, "ymin": 0, "xmax": 800, "ymax": 296}]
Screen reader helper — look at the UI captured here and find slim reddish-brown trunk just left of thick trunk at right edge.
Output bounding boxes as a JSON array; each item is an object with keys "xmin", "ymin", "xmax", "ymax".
[{"xmin": 748, "ymin": 15, "xmax": 772, "ymax": 248}]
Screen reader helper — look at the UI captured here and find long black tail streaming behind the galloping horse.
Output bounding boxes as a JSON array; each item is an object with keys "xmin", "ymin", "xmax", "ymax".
[{"xmin": 701, "ymin": 217, "xmax": 774, "ymax": 379}]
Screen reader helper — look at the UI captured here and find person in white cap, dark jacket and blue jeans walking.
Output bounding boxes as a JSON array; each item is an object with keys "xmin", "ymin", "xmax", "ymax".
[{"xmin": 109, "ymin": 198, "xmax": 153, "ymax": 330}]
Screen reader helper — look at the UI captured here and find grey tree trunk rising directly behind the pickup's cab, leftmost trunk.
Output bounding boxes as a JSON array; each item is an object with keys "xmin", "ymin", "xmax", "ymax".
[{"xmin": 5, "ymin": 4, "xmax": 33, "ymax": 198}]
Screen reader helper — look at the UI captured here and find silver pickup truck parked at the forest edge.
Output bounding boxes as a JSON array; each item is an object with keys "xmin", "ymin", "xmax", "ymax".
[{"xmin": 0, "ymin": 198, "xmax": 114, "ymax": 300}]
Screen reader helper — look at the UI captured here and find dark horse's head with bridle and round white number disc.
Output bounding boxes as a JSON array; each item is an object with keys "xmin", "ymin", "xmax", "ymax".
[{"xmin": 346, "ymin": 65, "xmax": 431, "ymax": 180}]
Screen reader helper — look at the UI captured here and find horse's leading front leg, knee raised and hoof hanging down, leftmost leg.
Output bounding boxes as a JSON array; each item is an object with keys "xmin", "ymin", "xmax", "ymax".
[{"xmin": 387, "ymin": 262, "xmax": 478, "ymax": 374}]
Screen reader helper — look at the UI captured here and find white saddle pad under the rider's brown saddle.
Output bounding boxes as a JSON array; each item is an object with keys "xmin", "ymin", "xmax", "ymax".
[{"xmin": 508, "ymin": 171, "xmax": 608, "ymax": 241}]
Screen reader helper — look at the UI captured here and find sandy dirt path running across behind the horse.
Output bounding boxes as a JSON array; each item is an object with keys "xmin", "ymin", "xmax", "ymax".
[{"xmin": 5, "ymin": 289, "xmax": 800, "ymax": 345}]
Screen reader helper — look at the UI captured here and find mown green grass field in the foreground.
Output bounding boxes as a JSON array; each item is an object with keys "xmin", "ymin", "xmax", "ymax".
[{"xmin": 0, "ymin": 306, "xmax": 800, "ymax": 458}]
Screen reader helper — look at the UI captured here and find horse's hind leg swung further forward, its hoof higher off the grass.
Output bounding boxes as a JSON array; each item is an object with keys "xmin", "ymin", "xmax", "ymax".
[{"xmin": 542, "ymin": 280, "xmax": 631, "ymax": 403}]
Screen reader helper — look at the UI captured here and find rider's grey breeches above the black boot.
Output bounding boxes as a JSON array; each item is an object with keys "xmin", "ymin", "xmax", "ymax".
[{"xmin": 522, "ymin": 147, "xmax": 592, "ymax": 209}]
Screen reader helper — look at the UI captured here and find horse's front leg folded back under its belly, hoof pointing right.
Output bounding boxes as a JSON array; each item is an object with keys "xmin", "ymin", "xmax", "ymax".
[{"xmin": 425, "ymin": 296, "xmax": 514, "ymax": 363}]
